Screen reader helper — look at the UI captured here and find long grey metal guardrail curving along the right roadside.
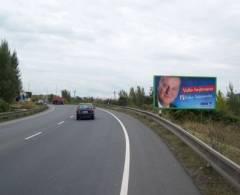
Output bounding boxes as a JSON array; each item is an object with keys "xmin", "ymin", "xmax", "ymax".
[{"xmin": 109, "ymin": 107, "xmax": 240, "ymax": 190}]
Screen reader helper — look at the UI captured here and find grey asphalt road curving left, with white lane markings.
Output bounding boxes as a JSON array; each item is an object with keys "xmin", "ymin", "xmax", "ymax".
[{"xmin": 0, "ymin": 105, "xmax": 200, "ymax": 195}]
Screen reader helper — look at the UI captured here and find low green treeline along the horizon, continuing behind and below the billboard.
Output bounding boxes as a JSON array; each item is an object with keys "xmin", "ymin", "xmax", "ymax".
[{"xmin": 32, "ymin": 84, "xmax": 240, "ymax": 122}]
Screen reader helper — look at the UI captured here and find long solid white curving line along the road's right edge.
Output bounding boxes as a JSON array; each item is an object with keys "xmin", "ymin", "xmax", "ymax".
[{"xmin": 100, "ymin": 109, "xmax": 130, "ymax": 195}]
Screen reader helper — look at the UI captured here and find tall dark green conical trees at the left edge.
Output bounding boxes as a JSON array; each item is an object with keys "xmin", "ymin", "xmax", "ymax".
[{"xmin": 0, "ymin": 40, "xmax": 22, "ymax": 111}]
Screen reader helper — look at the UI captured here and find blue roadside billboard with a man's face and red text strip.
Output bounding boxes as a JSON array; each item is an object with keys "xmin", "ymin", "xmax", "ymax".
[{"xmin": 153, "ymin": 75, "xmax": 216, "ymax": 109}]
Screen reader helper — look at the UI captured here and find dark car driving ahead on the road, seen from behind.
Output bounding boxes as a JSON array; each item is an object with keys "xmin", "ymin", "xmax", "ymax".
[{"xmin": 76, "ymin": 103, "xmax": 95, "ymax": 120}]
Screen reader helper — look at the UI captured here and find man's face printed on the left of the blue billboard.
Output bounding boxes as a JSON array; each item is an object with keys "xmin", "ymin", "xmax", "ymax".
[{"xmin": 158, "ymin": 77, "xmax": 180, "ymax": 106}]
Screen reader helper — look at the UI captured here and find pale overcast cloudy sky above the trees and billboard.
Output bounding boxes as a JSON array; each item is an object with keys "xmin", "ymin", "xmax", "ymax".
[{"xmin": 0, "ymin": 0, "xmax": 240, "ymax": 98}]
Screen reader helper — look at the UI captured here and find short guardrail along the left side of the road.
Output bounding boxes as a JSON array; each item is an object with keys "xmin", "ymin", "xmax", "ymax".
[{"xmin": 0, "ymin": 106, "xmax": 48, "ymax": 121}]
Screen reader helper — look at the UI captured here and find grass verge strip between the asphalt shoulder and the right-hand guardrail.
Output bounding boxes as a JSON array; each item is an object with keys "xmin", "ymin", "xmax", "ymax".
[{"xmin": 110, "ymin": 107, "xmax": 240, "ymax": 195}]
